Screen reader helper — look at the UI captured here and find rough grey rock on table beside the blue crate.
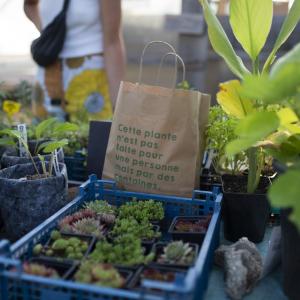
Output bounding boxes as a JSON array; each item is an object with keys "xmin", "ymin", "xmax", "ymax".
[{"xmin": 215, "ymin": 238, "xmax": 263, "ymax": 300}]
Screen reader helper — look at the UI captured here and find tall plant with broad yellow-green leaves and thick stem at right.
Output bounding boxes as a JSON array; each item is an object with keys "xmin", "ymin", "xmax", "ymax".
[{"xmin": 199, "ymin": 0, "xmax": 300, "ymax": 193}]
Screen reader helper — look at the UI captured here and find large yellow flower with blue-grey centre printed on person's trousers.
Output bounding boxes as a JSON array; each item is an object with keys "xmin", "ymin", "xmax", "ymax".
[{"xmin": 65, "ymin": 70, "xmax": 112, "ymax": 120}]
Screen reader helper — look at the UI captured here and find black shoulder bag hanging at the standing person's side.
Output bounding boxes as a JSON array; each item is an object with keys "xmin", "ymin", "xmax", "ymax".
[{"xmin": 31, "ymin": 0, "xmax": 70, "ymax": 67}]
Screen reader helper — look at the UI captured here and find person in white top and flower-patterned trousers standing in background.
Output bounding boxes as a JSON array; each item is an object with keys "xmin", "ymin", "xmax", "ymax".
[{"xmin": 24, "ymin": 0, "xmax": 125, "ymax": 120}]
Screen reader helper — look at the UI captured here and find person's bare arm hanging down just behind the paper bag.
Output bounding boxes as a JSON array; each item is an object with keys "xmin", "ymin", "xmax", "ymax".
[{"xmin": 99, "ymin": 0, "xmax": 125, "ymax": 107}]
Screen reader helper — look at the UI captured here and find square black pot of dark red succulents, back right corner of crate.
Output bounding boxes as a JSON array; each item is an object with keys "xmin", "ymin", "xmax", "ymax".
[{"xmin": 168, "ymin": 216, "xmax": 210, "ymax": 245}]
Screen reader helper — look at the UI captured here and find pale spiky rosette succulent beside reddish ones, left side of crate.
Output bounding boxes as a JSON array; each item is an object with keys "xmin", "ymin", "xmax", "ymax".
[{"xmin": 71, "ymin": 218, "xmax": 105, "ymax": 239}]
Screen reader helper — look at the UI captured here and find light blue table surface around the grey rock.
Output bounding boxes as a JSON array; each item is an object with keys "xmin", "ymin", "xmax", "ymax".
[{"xmin": 204, "ymin": 227, "xmax": 288, "ymax": 300}]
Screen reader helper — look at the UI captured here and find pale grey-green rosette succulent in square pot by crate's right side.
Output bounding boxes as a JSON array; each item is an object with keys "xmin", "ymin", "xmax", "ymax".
[{"xmin": 158, "ymin": 241, "xmax": 195, "ymax": 265}]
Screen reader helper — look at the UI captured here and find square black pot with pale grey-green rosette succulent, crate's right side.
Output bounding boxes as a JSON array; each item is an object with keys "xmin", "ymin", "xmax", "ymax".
[{"xmin": 152, "ymin": 241, "xmax": 199, "ymax": 268}]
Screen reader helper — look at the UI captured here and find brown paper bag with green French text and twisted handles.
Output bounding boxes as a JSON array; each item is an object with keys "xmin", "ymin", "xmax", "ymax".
[{"xmin": 103, "ymin": 42, "xmax": 209, "ymax": 197}]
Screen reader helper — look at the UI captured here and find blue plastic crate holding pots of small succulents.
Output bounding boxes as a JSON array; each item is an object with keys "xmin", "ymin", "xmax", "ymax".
[{"xmin": 0, "ymin": 175, "xmax": 222, "ymax": 300}]
